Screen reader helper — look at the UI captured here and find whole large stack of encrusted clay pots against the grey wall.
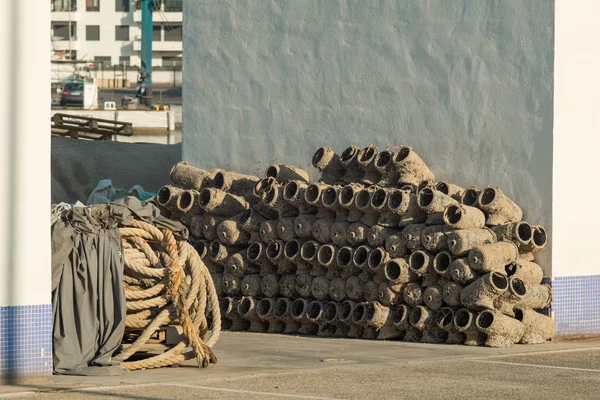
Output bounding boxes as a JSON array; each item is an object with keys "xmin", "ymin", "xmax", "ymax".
[{"xmin": 157, "ymin": 145, "xmax": 554, "ymax": 347}]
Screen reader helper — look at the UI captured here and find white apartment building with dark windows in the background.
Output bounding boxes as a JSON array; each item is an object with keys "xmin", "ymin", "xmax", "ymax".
[{"xmin": 51, "ymin": 0, "xmax": 183, "ymax": 70}]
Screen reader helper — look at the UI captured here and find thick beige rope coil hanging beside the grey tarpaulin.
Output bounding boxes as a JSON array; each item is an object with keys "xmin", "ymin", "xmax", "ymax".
[{"xmin": 116, "ymin": 220, "xmax": 221, "ymax": 370}]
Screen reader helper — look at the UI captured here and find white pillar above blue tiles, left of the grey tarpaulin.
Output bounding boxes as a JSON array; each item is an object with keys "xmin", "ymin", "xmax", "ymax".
[{"xmin": 0, "ymin": 1, "xmax": 51, "ymax": 306}]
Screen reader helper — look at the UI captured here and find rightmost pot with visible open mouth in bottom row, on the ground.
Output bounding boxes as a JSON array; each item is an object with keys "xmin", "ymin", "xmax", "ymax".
[{"xmin": 475, "ymin": 310, "xmax": 525, "ymax": 347}]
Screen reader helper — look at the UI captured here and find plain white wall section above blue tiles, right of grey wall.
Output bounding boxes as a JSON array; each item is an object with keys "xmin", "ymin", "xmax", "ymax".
[{"xmin": 552, "ymin": 0, "xmax": 600, "ymax": 276}]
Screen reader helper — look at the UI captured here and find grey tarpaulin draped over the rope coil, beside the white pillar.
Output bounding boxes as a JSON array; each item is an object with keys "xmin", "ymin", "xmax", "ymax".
[{"xmin": 52, "ymin": 197, "xmax": 187, "ymax": 375}]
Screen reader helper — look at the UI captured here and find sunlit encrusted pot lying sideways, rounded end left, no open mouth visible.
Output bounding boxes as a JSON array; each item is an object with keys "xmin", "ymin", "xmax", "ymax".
[{"xmin": 469, "ymin": 242, "xmax": 519, "ymax": 273}]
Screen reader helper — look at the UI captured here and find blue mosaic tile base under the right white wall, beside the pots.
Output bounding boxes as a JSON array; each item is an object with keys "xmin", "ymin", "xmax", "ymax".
[{"xmin": 552, "ymin": 275, "xmax": 600, "ymax": 336}]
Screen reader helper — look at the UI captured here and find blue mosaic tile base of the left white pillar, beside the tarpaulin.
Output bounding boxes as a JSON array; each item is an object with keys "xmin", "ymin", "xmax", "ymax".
[{"xmin": 0, "ymin": 304, "xmax": 52, "ymax": 375}]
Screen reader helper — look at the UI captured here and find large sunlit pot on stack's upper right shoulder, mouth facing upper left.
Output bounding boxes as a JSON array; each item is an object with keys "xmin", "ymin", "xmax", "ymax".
[{"xmin": 477, "ymin": 186, "xmax": 523, "ymax": 226}]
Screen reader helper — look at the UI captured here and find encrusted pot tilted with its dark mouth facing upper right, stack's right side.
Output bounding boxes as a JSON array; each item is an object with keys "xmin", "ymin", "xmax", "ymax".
[{"xmin": 460, "ymin": 272, "xmax": 508, "ymax": 311}]
